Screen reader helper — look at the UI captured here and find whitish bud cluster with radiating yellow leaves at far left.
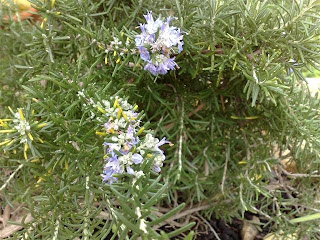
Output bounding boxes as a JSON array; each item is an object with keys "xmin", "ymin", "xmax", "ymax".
[{"xmin": 0, "ymin": 107, "xmax": 47, "ymax": 159}]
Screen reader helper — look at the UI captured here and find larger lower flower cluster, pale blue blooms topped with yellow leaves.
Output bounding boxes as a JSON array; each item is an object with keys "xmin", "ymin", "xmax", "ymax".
[{"xmin": 78, "ymin": 91, "xmax": 169, "ymax": 184}]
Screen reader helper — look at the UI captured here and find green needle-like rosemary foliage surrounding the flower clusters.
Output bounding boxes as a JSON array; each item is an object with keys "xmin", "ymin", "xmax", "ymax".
[{"xmin": 0, "ymin": 0, "xmax": 320, "ymax": 239}]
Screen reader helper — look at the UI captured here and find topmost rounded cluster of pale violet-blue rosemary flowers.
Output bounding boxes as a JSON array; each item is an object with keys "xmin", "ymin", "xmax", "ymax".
[{"xmin": 135, "ymin": 12, "xmax": 183, "ymax": 75}]
